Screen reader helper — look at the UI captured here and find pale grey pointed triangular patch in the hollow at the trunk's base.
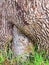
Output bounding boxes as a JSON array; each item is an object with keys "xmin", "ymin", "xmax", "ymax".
[{"xmin": 13, "ymin": 26, "xmax": 33, "ymax": 56}]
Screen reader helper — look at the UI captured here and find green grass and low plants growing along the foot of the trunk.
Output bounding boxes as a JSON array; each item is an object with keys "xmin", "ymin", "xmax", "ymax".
[{"xmin": 0, "ymin": 42, "xmax": 49, "ymax": 65}]
